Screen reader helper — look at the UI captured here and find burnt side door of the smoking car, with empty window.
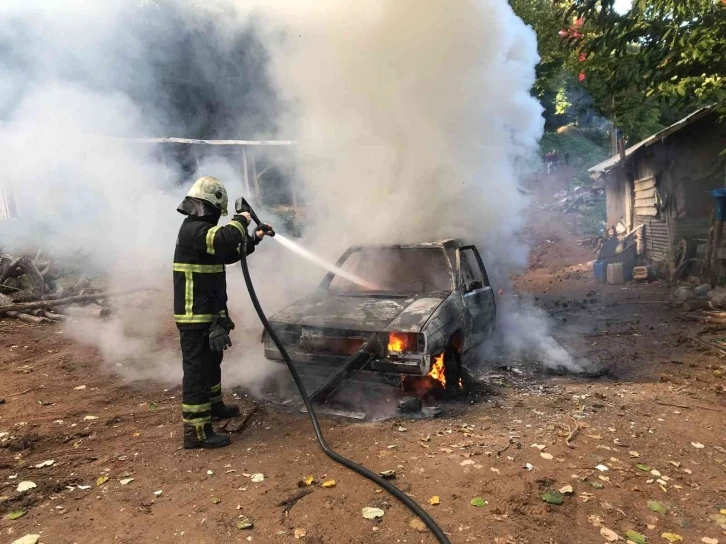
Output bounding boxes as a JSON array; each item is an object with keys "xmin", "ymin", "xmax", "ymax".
[{"xmin": 457, "ymin": 246, "xmax": 496, "ymax": 349}]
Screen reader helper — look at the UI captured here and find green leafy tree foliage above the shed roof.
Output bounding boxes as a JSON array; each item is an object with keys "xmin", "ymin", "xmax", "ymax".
[{"xmin": 561, "ymin": 0, "xmax": 726, "ymax": 119}]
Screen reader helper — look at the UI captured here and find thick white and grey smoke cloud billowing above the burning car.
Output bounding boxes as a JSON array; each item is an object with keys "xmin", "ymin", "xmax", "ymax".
[{"xmin": 0, "ymin": 0, "xmax": 584, "ymax": 394}]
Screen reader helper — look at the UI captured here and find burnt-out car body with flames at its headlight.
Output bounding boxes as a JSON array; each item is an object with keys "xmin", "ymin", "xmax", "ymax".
[{"xmin": 263, "ymin": 240, "xmax": 496, "ymax": 383}]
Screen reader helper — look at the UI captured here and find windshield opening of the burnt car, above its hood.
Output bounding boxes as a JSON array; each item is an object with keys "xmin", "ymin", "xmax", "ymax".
[{"xmin": 330, "ymin": 247, "xmax": 451, "ymax": 295}]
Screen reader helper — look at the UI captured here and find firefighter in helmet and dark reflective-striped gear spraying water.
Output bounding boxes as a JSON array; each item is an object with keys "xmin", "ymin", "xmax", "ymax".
[{"xmin": 174, "ymin": 176, "xmax": 265, "ymax": 448}]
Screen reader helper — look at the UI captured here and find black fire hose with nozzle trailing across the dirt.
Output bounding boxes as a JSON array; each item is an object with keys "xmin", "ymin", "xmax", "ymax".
[{"xmin": 235, "ymin": 198, "xmax": 450, "ymax": 544}]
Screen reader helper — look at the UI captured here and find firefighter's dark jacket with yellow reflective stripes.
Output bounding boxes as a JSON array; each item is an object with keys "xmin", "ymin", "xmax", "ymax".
[{"xmin": 174, "ymin": 215, "xmax": 259, "ymax": 329}]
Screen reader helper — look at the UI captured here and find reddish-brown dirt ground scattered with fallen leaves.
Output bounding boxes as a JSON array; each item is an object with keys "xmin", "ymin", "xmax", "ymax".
[{"xmin": 0, "ymin": 172, "xmax": 726, "ymax": 544}]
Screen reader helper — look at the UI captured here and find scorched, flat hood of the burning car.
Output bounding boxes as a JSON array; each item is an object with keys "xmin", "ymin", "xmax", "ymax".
[{"xmin": 270, "ymin": 292, "xmax": 450, "ymax": 332}]
